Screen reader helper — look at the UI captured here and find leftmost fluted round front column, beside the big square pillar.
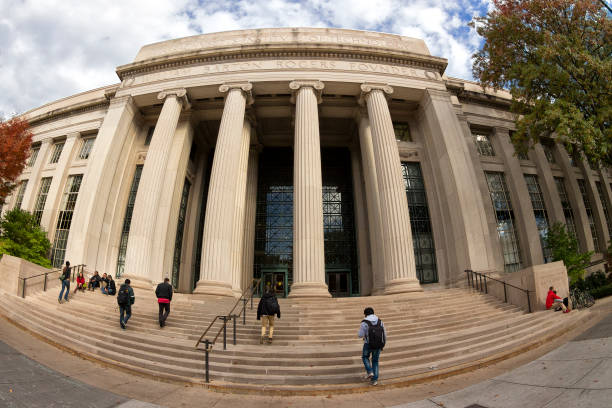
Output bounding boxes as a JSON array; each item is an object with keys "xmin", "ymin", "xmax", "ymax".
[{"xmin": 125, "ymin": 89, "xmax": 189, "ymax": 287}]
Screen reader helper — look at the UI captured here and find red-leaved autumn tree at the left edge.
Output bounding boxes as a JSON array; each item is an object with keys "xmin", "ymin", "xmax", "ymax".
[{"xmin": 0, "ymin": 118, "xmax": 32, "ymax": 205}]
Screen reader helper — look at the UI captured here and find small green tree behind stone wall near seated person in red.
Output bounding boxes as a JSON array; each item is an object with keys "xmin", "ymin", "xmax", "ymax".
[{"xmin": 546, "ymin": 222, "xmax": 593, "ymax": 284}]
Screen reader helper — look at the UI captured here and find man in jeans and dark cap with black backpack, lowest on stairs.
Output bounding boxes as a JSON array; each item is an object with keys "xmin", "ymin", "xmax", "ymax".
[{"xmin": 357, "ymin": 307, "xmax": 387, "ymax": 385}]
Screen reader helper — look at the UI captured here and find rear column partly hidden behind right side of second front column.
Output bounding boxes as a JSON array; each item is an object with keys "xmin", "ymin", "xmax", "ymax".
[{"xmin": 231, "ymin": 119, "xmax": 251, "ymax": 297}]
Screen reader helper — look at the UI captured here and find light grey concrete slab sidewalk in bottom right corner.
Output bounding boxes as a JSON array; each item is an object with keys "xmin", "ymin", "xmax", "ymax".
[{"xmin": 394, "ymin": 314, "xmax": 612, "ymax": 408}]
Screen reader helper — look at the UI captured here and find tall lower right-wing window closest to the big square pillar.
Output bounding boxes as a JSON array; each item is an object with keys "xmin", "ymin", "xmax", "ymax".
[{"xmin": 485, "ymin": 171, "xmax": 521, "ymax": 272}]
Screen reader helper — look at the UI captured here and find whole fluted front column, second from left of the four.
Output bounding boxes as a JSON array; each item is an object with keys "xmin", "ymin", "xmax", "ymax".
[{"xmin": 193, "ymin": 83, "xmax": 253, "ymax": 296}]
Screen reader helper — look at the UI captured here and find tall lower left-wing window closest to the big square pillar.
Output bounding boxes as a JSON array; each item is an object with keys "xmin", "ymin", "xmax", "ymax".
[{"xmin": 51, "ymin": 174, "xmax": 83, "ymax": 268}]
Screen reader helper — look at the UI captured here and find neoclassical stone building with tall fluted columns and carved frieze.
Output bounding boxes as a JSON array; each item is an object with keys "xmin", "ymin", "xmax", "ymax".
[{"xmin": 5, "ymin": 28, "xmax": 612, "ymax": 297}]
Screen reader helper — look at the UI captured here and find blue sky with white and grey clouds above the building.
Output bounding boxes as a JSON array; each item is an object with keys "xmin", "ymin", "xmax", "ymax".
[{"xmin": 0, "ymin": 0, "xmax": 489, "ymax": 118}]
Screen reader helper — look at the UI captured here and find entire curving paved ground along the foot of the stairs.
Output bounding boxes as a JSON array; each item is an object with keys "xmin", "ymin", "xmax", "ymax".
[{"xmin": 0, "ymin": 298, "xmax": 612, "ymax": 408}]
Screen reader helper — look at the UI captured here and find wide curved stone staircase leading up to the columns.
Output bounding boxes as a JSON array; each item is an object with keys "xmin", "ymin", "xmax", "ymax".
[{"xmin": 0, "ymin": 289, "xmax": 589, "ymax": 395}]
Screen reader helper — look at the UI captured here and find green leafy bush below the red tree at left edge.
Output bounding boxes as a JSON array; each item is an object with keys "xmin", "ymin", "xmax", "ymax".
[{"xmin": 0, "ymin": 209, "xmax": 51, "ymax": 268}]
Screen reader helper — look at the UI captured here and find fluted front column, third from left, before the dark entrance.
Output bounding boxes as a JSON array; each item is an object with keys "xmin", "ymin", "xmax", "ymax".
[{"xmin": 289, "ymin": 81, "xmax": 331, "ymax": 297}]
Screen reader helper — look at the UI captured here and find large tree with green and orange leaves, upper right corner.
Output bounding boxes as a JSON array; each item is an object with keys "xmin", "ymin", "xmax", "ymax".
[{"xmin": 470, "ymin": 0, "xmax": 612, "ymax": 165}]
